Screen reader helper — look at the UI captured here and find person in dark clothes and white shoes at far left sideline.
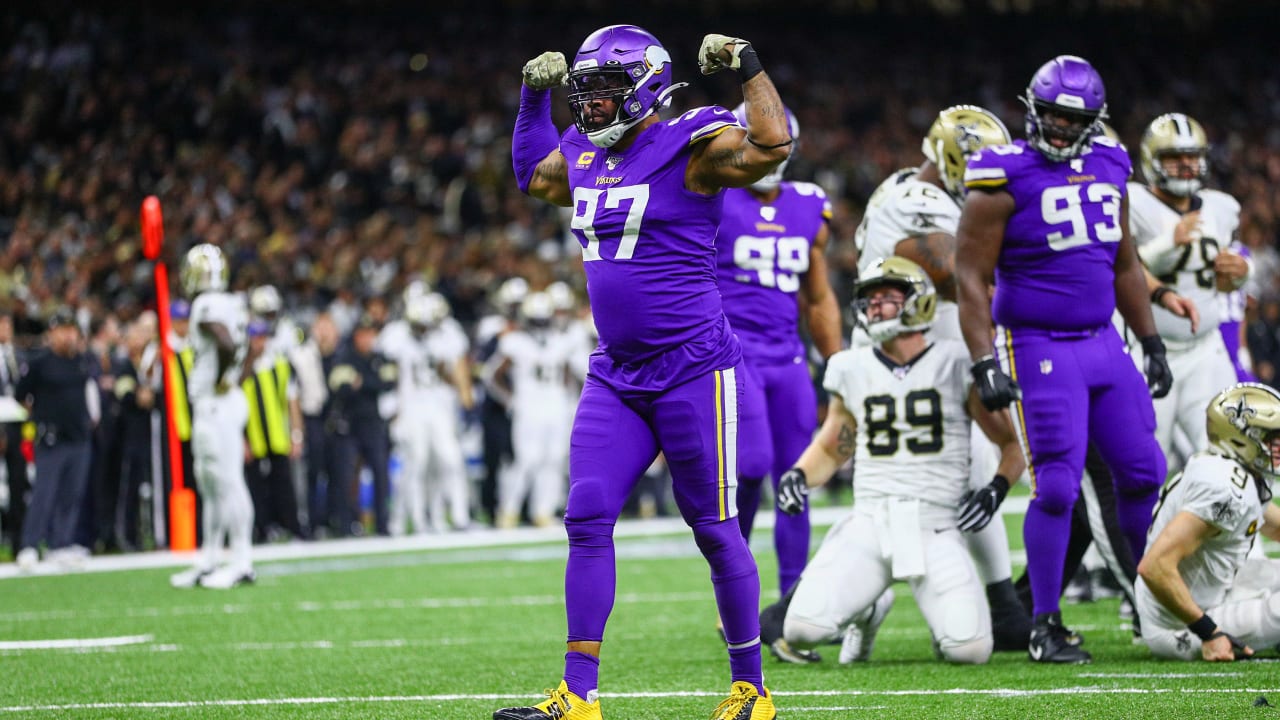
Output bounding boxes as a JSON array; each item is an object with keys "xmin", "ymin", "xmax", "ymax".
[{"xmin": 14, "ymin": 309, "xmax": 96, "ymax": 570}]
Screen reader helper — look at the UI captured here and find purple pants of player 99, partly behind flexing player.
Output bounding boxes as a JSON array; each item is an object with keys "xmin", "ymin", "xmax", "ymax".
[{"xmin": 737, "ymin": 360, "xmax": 818, "ymax": 594}]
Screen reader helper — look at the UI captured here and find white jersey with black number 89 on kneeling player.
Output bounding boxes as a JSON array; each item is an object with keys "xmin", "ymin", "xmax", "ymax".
[{"xmin": 823, "ymin": 340, "xmax": 973, "ymax": 510}]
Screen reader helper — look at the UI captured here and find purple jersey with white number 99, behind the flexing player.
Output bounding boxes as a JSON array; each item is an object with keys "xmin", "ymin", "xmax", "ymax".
[{"xmin": 716, "ymin": 182, "xmax": 831, "ymax": 361}]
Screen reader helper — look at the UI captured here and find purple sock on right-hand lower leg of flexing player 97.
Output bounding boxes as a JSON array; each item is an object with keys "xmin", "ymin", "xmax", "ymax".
[{"xmin": 694, "ymin": 518, "xmax": 764, "ymax": 693}]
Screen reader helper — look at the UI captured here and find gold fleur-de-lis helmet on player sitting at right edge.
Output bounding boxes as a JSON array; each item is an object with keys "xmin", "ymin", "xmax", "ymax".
[{"xmin": 1204, "ymin": 383, "xmax": 1280, "ymax": 484}]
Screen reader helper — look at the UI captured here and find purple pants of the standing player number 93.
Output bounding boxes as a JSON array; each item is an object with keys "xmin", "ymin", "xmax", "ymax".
[{"xmin": 996, "ymin": 324, "xmax": 1165, "ymax": 615}]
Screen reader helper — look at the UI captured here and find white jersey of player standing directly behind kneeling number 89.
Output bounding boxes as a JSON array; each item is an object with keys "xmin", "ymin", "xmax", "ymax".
[{"xmin": 854, "ymin": 168, "xmax": 963, "ymax": 340}]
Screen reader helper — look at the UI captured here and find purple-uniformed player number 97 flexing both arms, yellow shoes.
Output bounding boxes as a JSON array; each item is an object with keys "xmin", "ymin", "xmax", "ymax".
[{"xmin": 504, "ymin": 26, "xmax": 791, "ymax": 720}]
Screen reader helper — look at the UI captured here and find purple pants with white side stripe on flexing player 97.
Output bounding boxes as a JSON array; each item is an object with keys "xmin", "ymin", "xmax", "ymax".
[{"xmin": 564, "ymin": 364, "xmax": 763, "ymax": 687}]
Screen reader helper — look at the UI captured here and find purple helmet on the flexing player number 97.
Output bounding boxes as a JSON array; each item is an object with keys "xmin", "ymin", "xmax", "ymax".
[{"xmin": 568, "ymin": 26, "xmax": 685, "ymax": 147}]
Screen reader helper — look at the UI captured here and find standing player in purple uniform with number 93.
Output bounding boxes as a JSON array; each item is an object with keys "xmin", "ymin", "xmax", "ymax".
[{"xmin": 956, "ymin": 55, "xmax": 1171, "ymax": 662}]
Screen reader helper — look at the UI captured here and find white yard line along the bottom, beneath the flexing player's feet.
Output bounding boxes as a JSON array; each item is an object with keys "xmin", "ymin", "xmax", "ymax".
[{"xmin": 0, "ymin": 685, "xmax": 1280, "ymax": 712}]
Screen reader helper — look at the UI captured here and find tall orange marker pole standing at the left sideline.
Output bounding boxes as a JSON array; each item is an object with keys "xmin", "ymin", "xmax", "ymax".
[{"xmin": 142, "ymin": 195, "xmax": 196, "ymax": 551}]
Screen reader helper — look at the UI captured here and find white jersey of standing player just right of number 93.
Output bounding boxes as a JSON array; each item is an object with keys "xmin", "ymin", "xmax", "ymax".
[{"xmin": 1129, "ymin": 182, "xmax": 1240, "ymax": 341}]
